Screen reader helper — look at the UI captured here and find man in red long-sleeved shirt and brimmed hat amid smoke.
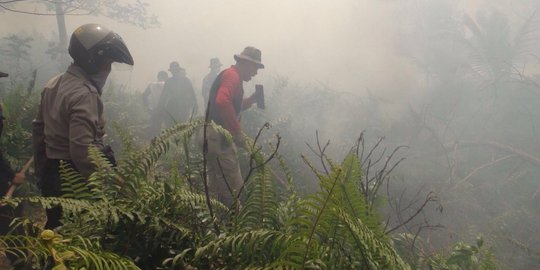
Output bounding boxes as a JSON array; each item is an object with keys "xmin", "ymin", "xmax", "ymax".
[{"xmin": 206, "ymin": 47, "xmax": 264, "ymax": 206}]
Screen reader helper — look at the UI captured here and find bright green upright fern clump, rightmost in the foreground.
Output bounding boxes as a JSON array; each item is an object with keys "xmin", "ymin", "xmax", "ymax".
[{"xmin": 286, "ymin": 153, "xmax": 407, "ymax": 269}]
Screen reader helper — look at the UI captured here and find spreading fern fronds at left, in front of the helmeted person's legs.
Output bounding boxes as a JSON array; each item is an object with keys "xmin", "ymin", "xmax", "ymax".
[{"xmin": 0, "ymin": 119, "xmax": 219, "ymax": 268}]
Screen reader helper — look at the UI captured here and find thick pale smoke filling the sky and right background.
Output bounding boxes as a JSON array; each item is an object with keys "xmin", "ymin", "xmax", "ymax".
[{"xmin": 0, "ymin": 0, "xmax": 540, "ymax": 269}]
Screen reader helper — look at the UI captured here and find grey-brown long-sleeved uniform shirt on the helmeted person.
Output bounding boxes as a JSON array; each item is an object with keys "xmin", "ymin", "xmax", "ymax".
[{"xmin": 32, "ymin": 65, "xmax": 105, "ymax": 177}]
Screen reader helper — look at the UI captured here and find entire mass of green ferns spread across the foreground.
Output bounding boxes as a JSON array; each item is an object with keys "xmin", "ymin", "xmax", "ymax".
[{"xmin": 0, "ymin": 80, "xmax": 422, "ymax": 269}]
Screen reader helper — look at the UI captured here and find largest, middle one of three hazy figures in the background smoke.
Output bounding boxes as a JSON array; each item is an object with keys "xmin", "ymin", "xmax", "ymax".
[{"xmin": 158, "ymin": 61, "xmax": 198, "ymax": 127}]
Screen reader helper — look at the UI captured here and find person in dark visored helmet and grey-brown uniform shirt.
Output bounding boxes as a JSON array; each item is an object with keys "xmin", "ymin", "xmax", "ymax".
[{"xmin": 32, "ymin": 24, "xmax": 133, "ymax": 229}]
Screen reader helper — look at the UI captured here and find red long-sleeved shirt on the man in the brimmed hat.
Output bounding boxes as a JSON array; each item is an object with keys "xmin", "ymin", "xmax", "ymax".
[{"xmin": 216, "ymin": 66, "xmax": 255, "ymax": 136}]
